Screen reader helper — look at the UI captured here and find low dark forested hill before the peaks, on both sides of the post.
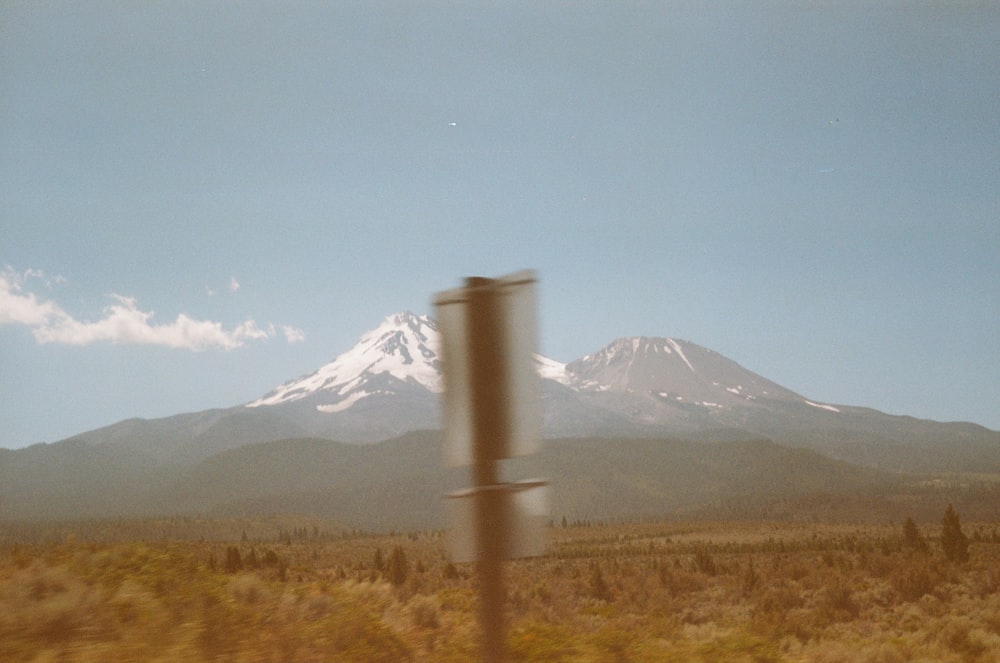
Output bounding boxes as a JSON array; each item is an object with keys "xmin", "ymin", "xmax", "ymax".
[{"xmin": 179, "ymin": 433, "xmax": 916, "ymax": 530}]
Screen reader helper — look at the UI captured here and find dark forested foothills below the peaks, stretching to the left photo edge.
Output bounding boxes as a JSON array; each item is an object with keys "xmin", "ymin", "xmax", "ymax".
[{"xmin": 0, "ymin": 432, "xmax": 898, "ymax": 529}]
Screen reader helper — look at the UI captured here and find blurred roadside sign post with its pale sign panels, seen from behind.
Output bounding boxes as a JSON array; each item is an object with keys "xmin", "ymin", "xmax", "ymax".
[{"xmin": 434, "ymin": 271, "xmax": 546, "ymax": 662}]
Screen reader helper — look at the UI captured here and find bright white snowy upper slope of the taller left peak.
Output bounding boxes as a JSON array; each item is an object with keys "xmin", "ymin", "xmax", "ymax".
[{"xmin": 247, "ymin": 311, "xmax": 443, "ymax": 413}]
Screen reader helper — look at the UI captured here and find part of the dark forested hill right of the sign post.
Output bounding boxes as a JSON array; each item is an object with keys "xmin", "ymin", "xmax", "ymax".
[{"xmin": 517, "ymin": 438, "xmax": 897, "ymax": 519}]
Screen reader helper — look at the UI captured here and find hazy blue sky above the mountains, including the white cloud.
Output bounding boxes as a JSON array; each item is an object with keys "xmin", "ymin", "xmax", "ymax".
[{"xmin": 0, "ymin": 0, "xmax": 1000, "ymax": 447}]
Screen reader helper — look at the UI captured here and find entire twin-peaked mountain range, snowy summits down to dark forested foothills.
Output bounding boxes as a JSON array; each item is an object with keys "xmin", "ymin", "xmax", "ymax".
[{"xmin": 0, "ymin": 312, "xmax": 1000, "ymax": 527}]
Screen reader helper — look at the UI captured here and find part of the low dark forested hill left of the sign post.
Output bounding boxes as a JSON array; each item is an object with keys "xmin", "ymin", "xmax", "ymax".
[{"xmin": 180, "ymin": 432, "xmax": 468, "ymax": 531}]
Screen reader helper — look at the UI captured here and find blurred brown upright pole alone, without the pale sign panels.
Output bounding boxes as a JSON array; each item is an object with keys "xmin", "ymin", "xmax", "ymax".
[{"xmin": 466, "ymin": 277, "xmax": 510, "ymax": 663}]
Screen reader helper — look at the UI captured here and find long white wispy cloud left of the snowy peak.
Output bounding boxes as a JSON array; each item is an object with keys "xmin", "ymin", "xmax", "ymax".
[{"xmin": 0, "ymin": 267, "xmax": 305, "ymax": 351}]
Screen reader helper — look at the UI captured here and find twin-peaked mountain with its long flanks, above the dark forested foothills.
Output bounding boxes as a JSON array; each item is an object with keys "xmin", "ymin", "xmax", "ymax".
[{"xmin": 19, "ymin": 311, "xmax": 1000, "ymax": 471}]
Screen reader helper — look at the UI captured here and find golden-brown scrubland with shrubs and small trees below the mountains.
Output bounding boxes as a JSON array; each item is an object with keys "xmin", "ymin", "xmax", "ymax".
[{"xmin": 0, "ymin": 514, "xmax": 1000, "ymax": 663}]
